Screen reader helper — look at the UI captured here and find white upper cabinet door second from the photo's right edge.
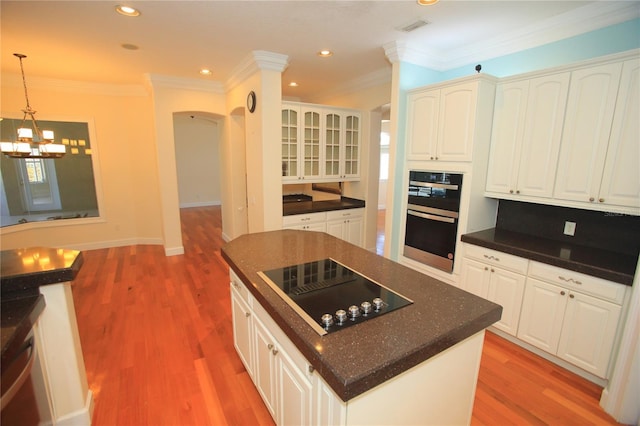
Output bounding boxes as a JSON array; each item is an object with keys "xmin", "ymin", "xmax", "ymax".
[{"xmin": 554, "ymin": 63, "xmax": 624, "ymax": 202}]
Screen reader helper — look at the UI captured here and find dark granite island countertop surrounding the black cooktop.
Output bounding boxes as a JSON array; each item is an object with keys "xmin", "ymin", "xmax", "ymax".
[{"xmin": 222, "ymin": 230, "xmax": 502, "ymax": 401}]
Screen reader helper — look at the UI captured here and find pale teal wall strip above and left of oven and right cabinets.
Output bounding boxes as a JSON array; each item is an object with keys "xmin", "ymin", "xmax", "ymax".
[{"xmin": 390, "ymin": 19, "xmax": 640, "ymax": 260}]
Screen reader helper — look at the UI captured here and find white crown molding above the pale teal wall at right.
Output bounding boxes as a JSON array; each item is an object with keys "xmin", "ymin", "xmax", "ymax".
[{"xmin": 383, "ymin": 1, "xmax": 640, "ymax": 71}]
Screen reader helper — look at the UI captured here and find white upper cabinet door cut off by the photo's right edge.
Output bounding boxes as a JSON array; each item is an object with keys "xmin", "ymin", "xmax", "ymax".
[{"xmin": 598, "ymin": 59, "xmax": 640, "ymax": 208}]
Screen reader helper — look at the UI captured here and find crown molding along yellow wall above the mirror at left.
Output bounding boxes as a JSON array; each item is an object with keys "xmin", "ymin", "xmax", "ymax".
[{"xmin": 1, "ymin": 73, "xmax": 148, "ymax": 96}]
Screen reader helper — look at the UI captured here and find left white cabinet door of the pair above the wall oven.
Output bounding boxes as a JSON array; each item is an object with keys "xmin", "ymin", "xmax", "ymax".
[{"xmin": 407, "ymin": 90, "xmax": 440, "ymax": 160}]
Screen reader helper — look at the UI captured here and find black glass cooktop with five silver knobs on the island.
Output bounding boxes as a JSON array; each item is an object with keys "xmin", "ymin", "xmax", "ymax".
[{"xmin": 258, "ymin": 259, "xmax": 413, "ymax": 335}]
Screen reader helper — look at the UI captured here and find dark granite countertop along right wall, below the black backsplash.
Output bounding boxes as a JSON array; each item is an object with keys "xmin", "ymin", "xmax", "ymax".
[{"xmin": 461, "ymin": 228, "xmax": 638, "ymax": 286}]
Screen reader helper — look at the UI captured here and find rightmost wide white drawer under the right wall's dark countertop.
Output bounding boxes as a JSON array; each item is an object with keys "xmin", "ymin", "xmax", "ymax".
[{"xmin": 529, "ymin": 261, "xmax": 626, "ymax": 305}]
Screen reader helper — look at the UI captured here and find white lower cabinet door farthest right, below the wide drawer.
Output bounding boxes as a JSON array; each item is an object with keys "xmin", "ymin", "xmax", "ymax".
[{"xmin": 558, "ymin": 292, "xmax": 621, "ymax": 377}]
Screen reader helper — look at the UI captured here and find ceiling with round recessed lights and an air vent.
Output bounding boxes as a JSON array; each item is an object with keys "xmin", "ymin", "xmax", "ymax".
[{"xmin": 0, "ymin": 0, "xmax": 640, "ymax": 100}]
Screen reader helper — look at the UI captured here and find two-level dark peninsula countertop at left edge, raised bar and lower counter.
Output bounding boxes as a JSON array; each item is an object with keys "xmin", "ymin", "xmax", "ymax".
[{"xmin": 0, "ymin": 247, "xmax": 83, "ymax": 366}]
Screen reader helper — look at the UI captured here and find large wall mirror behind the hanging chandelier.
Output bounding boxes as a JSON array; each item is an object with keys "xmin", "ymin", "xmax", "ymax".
[{"xmin": 0, "ymin": 118, "xmax": 100, "ymax": 227}]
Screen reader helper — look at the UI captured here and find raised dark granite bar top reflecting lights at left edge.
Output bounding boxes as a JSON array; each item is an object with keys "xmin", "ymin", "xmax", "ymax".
[{"xmin": 0, "ymin": 247, "xmax": 83, "ymax": 300}]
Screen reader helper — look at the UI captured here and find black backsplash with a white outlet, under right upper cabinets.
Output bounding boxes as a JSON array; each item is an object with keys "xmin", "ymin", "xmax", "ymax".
[{"xmin": 496, "ymin": 200, "xmax": 640, "ymax": 256}]
